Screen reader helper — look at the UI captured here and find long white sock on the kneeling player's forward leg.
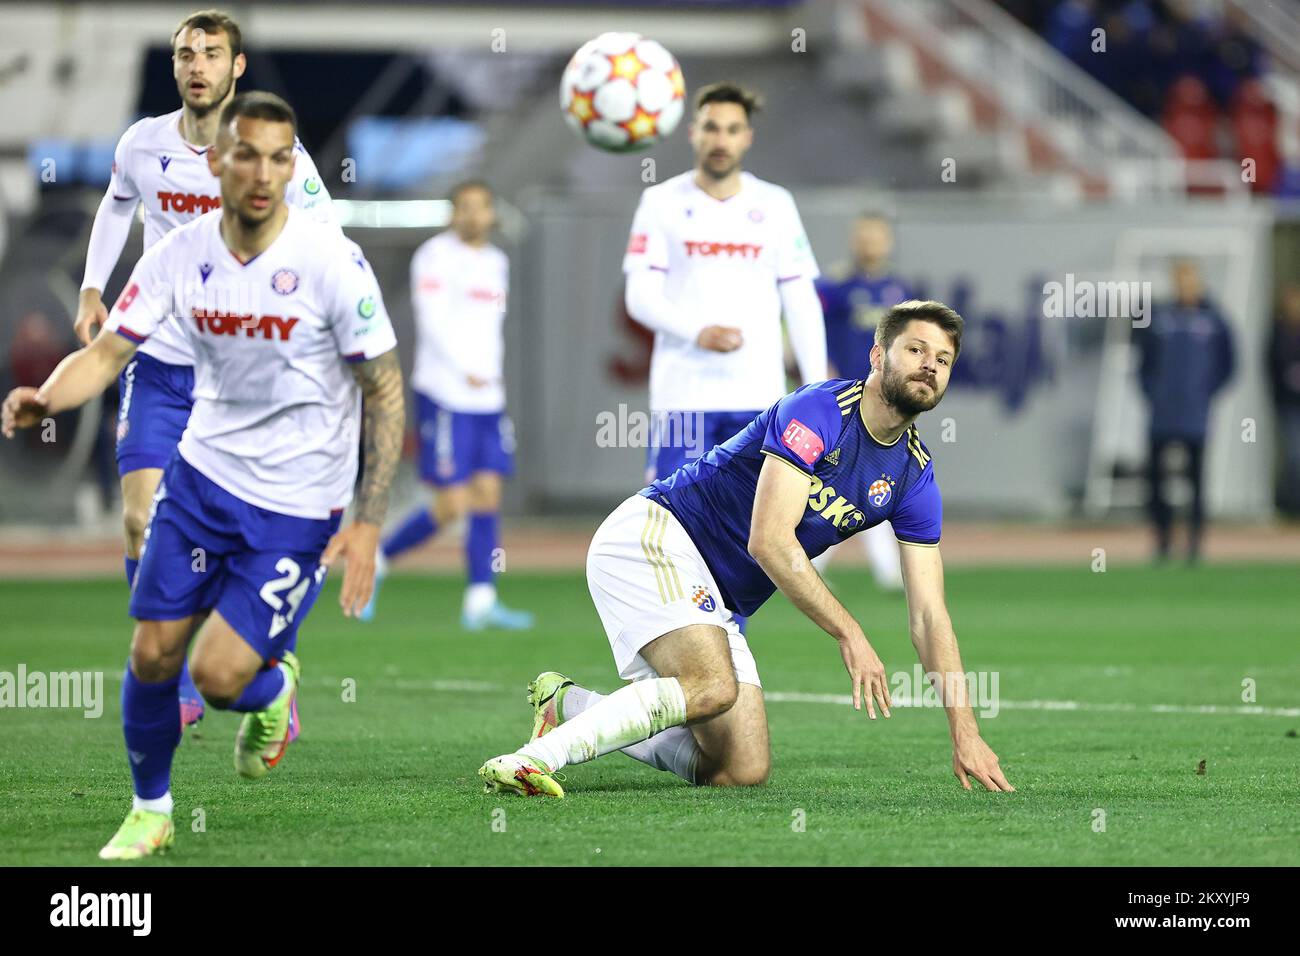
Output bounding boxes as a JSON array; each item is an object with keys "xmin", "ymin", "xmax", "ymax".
[{"xmin": 519, "ymin": 678, "xmax": 686, "ymax": 770}]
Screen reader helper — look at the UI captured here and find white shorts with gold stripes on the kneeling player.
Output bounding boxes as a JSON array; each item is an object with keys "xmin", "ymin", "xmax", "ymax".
[{"xmin": 586, "ymin": 494, "xmax": 763, "ymax": 687}]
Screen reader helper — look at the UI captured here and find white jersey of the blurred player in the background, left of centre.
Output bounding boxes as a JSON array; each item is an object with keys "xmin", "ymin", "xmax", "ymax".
[{"xmin": 411, "ymin": 229, "xmax": 510, "ymax": 412}]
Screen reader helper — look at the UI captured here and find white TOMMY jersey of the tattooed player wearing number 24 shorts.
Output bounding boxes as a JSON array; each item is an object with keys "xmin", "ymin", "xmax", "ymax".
[{"xmin": 105, "ymin": 208, "xmax": 397, "ymax": 518}]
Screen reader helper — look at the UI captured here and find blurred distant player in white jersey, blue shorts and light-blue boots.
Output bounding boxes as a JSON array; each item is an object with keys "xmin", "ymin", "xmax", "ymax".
[{"xmin": 361, "ymin": 179, "xmax": 533, "ymax": 631}]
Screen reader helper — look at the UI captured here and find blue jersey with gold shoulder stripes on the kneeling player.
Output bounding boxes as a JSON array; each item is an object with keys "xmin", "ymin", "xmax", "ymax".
[{"xmin": 640, "ymin": 378, "xmax": 943, "ymax": 615}]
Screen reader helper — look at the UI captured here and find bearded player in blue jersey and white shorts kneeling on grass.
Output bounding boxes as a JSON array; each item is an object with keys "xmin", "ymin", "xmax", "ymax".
[{"xmin": 478, "ymin": 300, "xmax": 1013, "ymax": 796}]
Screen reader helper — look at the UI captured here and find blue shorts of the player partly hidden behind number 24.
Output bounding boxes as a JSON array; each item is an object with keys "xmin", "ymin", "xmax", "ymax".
[{"xmin": 117, "ymin": 352, "xmax": 194, "ymax": 476}]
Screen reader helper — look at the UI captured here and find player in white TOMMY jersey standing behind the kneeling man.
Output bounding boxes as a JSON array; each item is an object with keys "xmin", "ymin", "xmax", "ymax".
[{"xmin": 623, "ymin": 83, "xmax": 827, "ymax": 634}]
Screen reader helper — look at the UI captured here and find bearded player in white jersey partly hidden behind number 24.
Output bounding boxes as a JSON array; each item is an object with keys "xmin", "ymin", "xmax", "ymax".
[{"xmin": 77, "ymin": 10, "xmax": 337, "ymax": 736}]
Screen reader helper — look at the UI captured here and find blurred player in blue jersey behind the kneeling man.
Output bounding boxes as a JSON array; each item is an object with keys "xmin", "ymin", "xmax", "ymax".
[{"xmin": 816, "ymin": 212, "xmax": 915, "ymax": 591}]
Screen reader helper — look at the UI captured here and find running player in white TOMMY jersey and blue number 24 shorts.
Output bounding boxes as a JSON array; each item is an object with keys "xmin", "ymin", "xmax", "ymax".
[{"xmin": 3, "ymin": 92, "xmax": 404, "ymax": 860}]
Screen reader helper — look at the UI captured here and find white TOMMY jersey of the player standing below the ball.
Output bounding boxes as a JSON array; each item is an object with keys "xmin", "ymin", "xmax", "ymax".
[{"xmin": 623, "ymin": 172, "xmax": 819, "ymax": 411}]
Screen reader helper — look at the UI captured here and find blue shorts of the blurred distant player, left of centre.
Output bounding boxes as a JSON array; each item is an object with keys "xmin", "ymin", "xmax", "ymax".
[{"xmin": 415, "ymin": 392, "xmax": 515, "ymax": 488}]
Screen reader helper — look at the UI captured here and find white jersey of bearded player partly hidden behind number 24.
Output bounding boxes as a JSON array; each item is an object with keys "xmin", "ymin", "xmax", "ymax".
[{"xmin": 108, "ymin": 109, "xmax": 338, "ymax": 365}]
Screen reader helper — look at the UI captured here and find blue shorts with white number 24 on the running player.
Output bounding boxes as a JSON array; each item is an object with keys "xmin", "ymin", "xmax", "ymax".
[{"xmin": 130, "ymin": 454, "xmax": 343, "ymax": 661}]
